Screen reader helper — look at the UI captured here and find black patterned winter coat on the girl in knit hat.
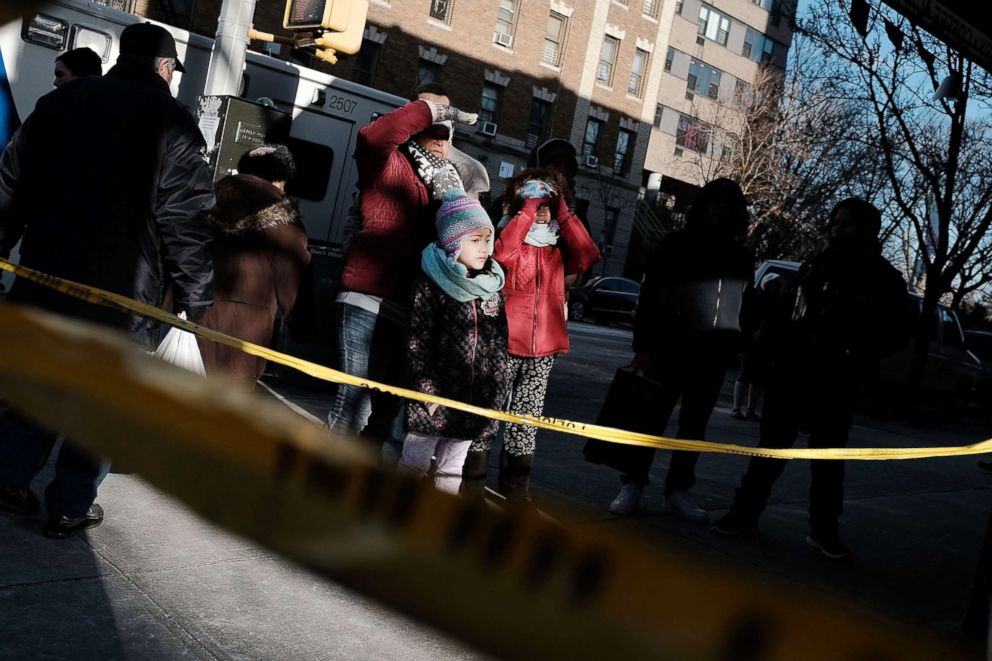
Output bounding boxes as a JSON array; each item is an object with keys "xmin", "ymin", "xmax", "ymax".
[{"xmin": 406, "ymin": 274, "xmax": 509, "ymax": 441}]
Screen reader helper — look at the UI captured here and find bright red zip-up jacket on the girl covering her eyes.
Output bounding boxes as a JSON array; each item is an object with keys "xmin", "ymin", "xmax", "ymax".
[{"xmin": 493, "ymin": 210, "xmax": 599, "ymax": 358}]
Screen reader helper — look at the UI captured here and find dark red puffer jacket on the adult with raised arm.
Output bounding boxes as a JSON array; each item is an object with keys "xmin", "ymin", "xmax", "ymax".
[{"xmin": 341, "ymin": 101, "xmax": 437, "ymax": 301}]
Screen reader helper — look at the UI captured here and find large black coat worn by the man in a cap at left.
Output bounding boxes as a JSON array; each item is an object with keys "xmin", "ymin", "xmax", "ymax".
[{"xmin": 0, "ymin": 62, "xmax": 213, "ymax": 345}]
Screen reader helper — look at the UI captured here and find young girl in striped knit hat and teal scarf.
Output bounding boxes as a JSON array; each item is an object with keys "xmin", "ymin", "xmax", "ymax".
[{"xmin": 399, "ymin": 191, "xmax": 510, "ymax": 494}]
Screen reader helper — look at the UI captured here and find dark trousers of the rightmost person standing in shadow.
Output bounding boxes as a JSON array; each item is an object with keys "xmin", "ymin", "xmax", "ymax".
[{"xmin": 732, "ymin": 372, "xmax": 859, "ymax": 530}]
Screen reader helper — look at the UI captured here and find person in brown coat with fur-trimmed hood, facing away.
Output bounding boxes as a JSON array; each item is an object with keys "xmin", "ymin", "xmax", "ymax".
[{"xmin": 199, "ymin": 145, "xmax": 310, "ymax": 389}]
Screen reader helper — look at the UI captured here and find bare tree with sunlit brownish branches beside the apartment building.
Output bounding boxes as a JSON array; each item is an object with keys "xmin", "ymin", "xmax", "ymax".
[{"xmin": 676, "ymin": 33, "xmax": 885, "ymax": 260}]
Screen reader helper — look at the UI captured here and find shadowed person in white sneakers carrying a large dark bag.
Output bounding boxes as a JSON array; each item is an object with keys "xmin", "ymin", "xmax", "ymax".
[{"xmin": 610, "ymin": 179, "xmax": 754, "ymax": 523}]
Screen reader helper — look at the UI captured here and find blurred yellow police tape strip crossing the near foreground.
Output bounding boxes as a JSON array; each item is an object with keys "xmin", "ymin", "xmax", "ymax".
[{"xmin": 0, "ymin": 304, "xmax": 962, "ymax": 661}]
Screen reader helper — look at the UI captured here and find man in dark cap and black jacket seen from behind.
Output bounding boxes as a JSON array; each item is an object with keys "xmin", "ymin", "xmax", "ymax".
[{"xmin": 0, "ymin": 23, "xmax": 213, "ymax": 537}]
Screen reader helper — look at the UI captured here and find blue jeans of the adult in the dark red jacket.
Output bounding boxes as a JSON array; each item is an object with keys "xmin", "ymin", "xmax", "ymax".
[{"xmin": 327, "ymin": 303, "xmax": 403, "ymax": 442}]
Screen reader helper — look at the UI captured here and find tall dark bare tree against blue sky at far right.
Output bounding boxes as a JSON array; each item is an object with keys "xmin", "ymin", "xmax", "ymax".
[{"xmin": 797, "ymin": 0, "xmax": 992, "ymax": 394}]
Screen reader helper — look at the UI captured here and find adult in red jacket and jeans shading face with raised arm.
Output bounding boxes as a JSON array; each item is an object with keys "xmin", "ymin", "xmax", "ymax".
[{"xmin": 327, "ymin": 82, "xmax": 477, "ymax": 446}]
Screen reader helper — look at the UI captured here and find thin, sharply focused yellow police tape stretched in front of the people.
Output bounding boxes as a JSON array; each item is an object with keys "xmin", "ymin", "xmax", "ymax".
[{"xmin": 0, "ymin": 259, "xmax": 992, "ymax": 460}]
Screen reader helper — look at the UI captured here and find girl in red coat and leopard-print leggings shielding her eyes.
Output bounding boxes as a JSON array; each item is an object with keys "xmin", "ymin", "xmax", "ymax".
[{"xmin": 464, "ymin": 168, "xmax": 599, "ymax": 499}]
